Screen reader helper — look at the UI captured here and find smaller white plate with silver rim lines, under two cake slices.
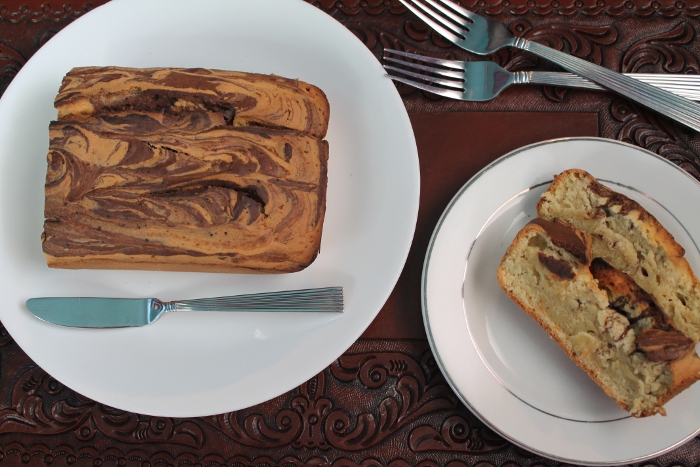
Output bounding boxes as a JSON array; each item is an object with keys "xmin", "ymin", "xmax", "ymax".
[{"xmin": 422, "ymin": 138, "xmax": 700, "ymax": 465}]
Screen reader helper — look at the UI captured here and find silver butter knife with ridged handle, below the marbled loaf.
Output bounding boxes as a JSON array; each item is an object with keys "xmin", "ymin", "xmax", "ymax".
[{"xmin": 27, "ymin": 287, "xmax": 343, "ymax": 328}]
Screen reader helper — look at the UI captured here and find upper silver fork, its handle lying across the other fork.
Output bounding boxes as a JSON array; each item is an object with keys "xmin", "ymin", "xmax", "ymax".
[{"xmin": 399, "ymin": 0, "xmax": 700, "ymax": 131}]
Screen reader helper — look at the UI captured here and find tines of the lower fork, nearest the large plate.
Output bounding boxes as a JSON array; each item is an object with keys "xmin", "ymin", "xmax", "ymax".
[{"xmin": 383, "ymin": 49, "xmax": 464, "ymax": 99}]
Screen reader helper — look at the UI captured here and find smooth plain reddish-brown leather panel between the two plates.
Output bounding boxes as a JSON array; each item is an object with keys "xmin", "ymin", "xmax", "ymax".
[{"xmin": 362, "ymin": 112, "xmax": 598, "ymax": 339}]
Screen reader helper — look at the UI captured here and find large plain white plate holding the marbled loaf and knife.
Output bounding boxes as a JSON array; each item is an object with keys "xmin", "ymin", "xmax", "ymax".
[{"xmin": 0, "ymin": 0, "xmax": 419, "ymax": 417}]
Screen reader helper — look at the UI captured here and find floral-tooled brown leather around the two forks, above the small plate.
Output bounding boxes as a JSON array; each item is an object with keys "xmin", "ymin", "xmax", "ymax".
[{"xmin": 341, "ymin": 10, "xmax": 700, "ymax": 178}]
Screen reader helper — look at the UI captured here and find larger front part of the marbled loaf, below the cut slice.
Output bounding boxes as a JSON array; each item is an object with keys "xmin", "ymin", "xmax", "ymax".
[{"xmin": 43, "ymin": 118, "xmax": 328, "ymax": 269}]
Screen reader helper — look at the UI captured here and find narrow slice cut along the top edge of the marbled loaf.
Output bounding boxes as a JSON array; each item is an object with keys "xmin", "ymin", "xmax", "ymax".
[{"xmin": 54, "ymin": 67, "xmax": 330, "ymax": 138}]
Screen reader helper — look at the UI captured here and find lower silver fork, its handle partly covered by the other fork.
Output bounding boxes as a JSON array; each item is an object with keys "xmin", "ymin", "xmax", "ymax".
[{"xmin": 383, "ymin": 49, "xmax": 700, "ymax": 102}]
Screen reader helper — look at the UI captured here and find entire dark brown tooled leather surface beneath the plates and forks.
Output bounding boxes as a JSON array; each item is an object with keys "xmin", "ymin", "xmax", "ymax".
[{"xmin": 0, "ymin": 0, "xmax": 700, "ymax": 467}]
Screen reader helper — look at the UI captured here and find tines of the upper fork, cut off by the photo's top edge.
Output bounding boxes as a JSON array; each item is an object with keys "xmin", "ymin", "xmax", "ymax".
[{"xmin": 399, "ymin": 0, "xmax": 474, "ymax": 42}]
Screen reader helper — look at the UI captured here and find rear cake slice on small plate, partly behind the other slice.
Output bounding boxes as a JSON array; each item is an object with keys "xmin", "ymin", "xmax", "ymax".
[{"xmin": 537, "ymin": 169, "xmax": 700, "ymax": 343}]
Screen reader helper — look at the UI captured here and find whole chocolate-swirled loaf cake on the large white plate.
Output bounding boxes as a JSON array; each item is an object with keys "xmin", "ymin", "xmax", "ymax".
[{"xmin": 42, "ymin": 67, "xmax": 329, "ymax": 272}]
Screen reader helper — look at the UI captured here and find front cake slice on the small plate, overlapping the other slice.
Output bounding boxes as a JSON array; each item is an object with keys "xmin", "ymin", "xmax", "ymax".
[{"xmin": 498, "ymin": 219, "xmax": 700, "ymax": 417}]
